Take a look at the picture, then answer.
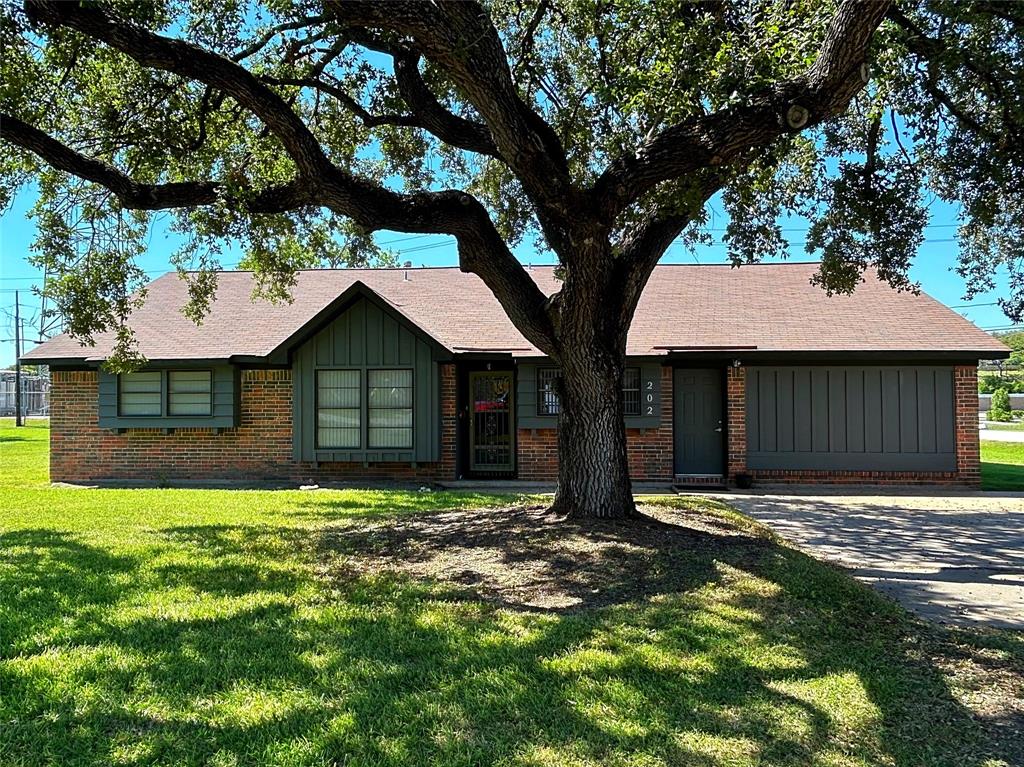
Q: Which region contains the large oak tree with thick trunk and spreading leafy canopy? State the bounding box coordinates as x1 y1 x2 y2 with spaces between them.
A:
0 0 1024 516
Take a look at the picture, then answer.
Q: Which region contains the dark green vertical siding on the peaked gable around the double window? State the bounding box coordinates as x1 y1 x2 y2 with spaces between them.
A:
292 298 440 463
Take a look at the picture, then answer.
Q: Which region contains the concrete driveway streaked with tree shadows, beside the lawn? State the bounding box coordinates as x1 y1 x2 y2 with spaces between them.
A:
722 493 1024 630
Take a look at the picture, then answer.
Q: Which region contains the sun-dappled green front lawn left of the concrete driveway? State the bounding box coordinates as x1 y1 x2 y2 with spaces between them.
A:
0 424 1021 767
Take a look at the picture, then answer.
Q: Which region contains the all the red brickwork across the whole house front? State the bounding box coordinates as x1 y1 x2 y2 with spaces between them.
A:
50 364 980 486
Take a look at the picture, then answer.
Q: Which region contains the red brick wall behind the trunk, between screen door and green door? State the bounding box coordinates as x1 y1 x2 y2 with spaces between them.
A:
516 368 673 482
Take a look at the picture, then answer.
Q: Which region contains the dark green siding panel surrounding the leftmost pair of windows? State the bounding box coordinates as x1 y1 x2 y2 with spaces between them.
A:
96 365 241 429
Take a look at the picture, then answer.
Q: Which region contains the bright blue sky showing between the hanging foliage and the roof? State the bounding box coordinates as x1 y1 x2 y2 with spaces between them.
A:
0 182 1009 368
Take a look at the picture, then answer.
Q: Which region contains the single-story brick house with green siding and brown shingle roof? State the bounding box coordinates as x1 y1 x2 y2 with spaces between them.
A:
24 263 1008 485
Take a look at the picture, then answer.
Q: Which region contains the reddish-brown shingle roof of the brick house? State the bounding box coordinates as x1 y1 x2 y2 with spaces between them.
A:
25 263 1007 361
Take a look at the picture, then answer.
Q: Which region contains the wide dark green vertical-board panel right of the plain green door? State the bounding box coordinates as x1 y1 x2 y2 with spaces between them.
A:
746 366 956 471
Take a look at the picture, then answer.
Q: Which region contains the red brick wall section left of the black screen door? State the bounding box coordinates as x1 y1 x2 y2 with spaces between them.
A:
50 365 455 482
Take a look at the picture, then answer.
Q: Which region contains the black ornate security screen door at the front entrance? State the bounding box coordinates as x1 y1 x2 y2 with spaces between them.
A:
469 371 515 474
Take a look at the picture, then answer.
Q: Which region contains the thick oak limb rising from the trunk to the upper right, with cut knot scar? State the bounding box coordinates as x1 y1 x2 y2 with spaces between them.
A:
593 0 889 219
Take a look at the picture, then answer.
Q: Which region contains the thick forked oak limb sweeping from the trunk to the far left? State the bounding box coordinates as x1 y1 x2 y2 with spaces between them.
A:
12 0 554 350
